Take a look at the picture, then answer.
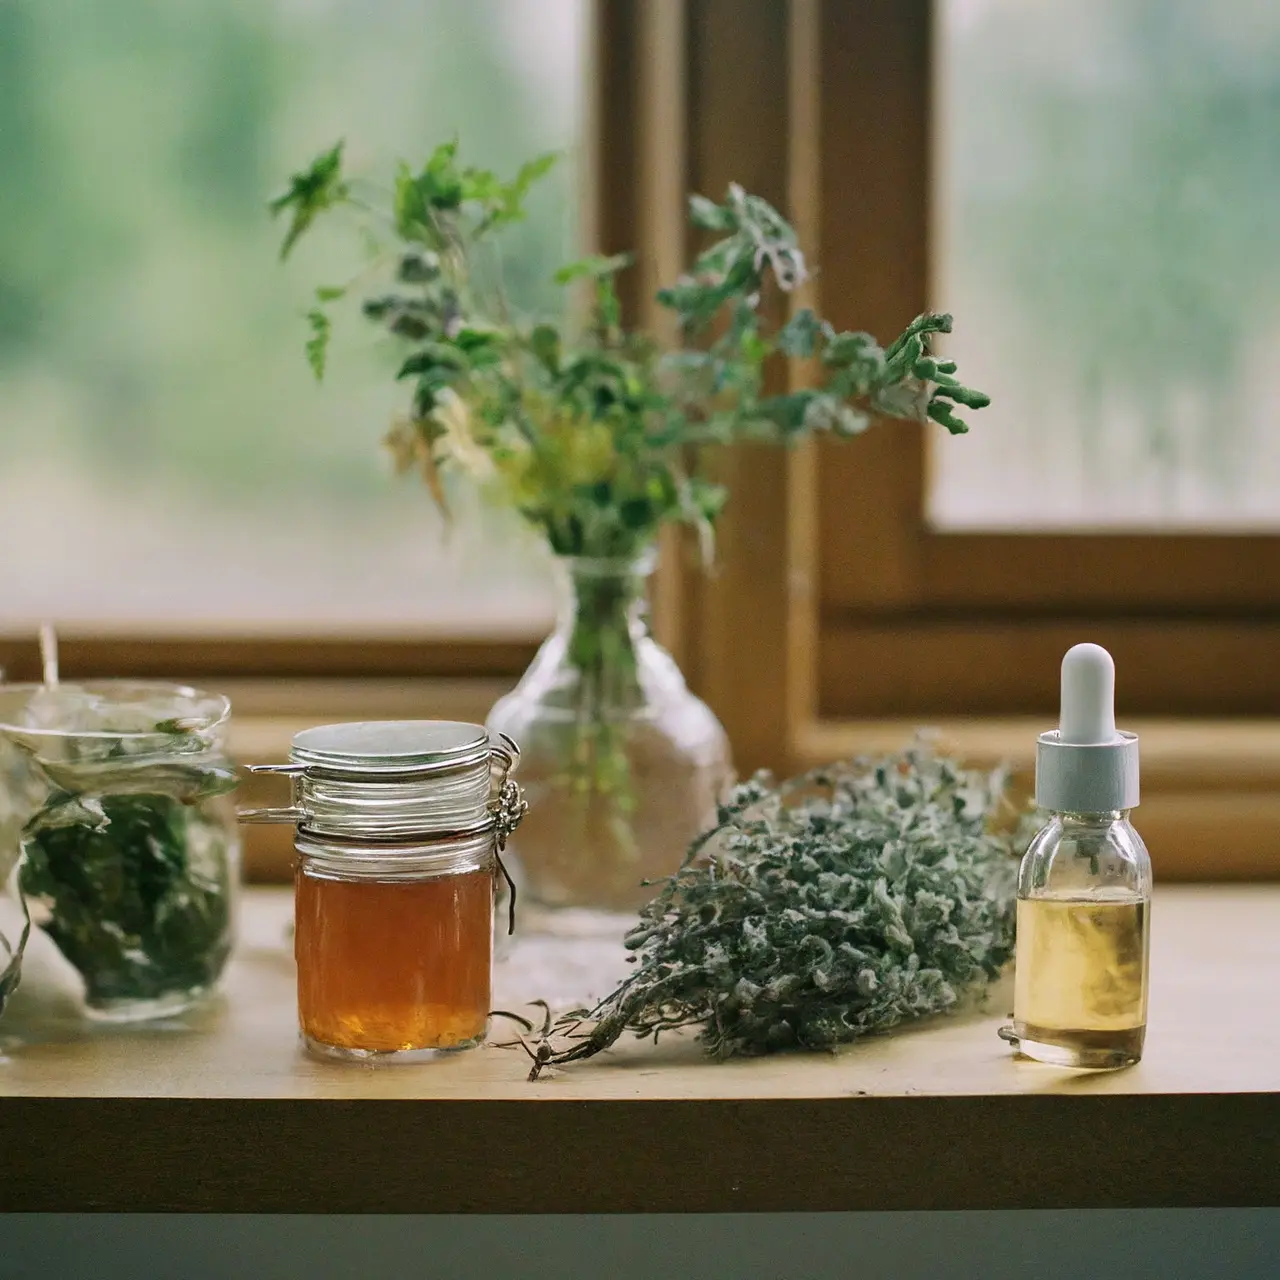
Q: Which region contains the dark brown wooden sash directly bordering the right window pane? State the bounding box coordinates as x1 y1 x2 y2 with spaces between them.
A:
814 0 1280 716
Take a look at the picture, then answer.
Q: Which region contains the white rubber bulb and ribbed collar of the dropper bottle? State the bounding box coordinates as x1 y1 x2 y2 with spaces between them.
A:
1036 644 1138 813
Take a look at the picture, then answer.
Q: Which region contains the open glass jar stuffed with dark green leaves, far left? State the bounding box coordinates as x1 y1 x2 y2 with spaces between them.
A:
0 681 239 1021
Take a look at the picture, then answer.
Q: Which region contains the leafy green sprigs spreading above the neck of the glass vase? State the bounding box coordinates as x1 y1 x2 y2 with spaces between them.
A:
271 142 988 558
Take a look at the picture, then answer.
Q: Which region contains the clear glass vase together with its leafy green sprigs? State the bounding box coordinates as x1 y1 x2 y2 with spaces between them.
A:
271 142 988 908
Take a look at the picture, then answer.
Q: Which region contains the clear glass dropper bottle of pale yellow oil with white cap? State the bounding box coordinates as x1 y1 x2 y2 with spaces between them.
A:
1002 644 1151 1068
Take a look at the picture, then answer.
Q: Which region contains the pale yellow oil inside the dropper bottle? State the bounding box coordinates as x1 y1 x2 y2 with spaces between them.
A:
1014 895 1151 1068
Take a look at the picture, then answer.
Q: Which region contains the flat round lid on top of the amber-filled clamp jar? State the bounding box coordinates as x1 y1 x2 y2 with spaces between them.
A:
289 721 490 774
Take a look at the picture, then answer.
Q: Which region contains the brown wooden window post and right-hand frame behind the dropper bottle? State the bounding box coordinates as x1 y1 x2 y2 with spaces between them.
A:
595 0 1280 878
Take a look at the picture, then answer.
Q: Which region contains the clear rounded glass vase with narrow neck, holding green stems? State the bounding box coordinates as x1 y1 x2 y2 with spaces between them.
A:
488 552 732 911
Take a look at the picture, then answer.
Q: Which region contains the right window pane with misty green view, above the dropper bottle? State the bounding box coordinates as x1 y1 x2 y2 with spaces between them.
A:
931 0 1280 531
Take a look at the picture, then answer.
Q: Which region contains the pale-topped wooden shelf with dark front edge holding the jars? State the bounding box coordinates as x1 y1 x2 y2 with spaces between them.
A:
0 886 1280 1212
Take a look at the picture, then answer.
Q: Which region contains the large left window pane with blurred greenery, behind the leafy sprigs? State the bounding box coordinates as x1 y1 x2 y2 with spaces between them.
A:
0 0 585 634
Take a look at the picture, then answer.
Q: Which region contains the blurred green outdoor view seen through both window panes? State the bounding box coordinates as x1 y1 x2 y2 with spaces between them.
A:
0 0 1280 632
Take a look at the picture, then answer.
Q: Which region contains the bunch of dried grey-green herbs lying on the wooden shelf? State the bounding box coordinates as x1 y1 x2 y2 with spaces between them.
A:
531 748 1025 1078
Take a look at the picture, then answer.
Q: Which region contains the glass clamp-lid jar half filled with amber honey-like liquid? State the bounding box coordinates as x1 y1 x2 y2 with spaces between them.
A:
241 721 526 1061
